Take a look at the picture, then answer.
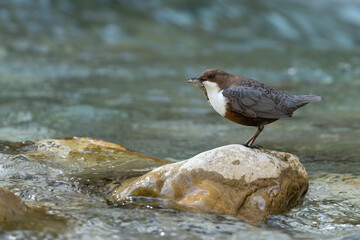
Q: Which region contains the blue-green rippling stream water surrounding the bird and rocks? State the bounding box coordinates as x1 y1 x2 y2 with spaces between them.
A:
0 0 360 239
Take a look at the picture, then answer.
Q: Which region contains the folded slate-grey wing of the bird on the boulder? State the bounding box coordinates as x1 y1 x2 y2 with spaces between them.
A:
223 86 291 119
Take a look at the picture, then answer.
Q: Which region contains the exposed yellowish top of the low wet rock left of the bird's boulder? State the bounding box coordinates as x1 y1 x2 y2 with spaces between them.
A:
24 136 168 170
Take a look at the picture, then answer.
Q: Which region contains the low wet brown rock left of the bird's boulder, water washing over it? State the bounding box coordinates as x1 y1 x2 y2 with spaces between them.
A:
0 136 169 196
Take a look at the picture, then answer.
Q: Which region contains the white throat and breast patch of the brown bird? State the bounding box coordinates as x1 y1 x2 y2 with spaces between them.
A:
203 81 227 116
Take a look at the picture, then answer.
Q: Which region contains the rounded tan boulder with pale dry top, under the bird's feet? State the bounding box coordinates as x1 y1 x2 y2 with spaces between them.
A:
108 145 308 222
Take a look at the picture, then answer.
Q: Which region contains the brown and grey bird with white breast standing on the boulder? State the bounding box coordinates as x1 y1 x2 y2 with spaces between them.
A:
188 68 322 148
